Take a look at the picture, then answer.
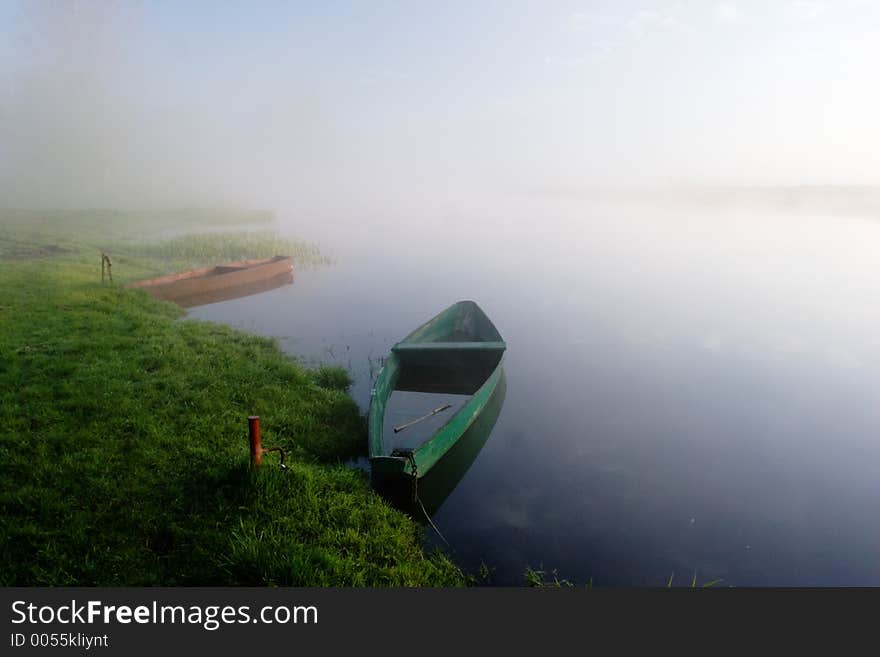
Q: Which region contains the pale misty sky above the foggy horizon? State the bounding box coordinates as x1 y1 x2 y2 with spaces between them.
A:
0 0 880 207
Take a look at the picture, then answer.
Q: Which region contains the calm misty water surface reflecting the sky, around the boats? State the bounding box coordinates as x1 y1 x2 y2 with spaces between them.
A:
190 199 880 586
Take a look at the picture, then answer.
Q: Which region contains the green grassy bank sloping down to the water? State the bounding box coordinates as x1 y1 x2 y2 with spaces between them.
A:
0 210 463 586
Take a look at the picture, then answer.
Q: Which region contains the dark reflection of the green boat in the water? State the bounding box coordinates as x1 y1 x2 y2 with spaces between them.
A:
373 367 507 521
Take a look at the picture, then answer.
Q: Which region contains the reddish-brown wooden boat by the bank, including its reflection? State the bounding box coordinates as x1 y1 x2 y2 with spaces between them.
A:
127 256 293 307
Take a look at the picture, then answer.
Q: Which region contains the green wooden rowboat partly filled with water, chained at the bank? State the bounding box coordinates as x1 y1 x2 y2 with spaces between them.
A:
369 301 507 483
